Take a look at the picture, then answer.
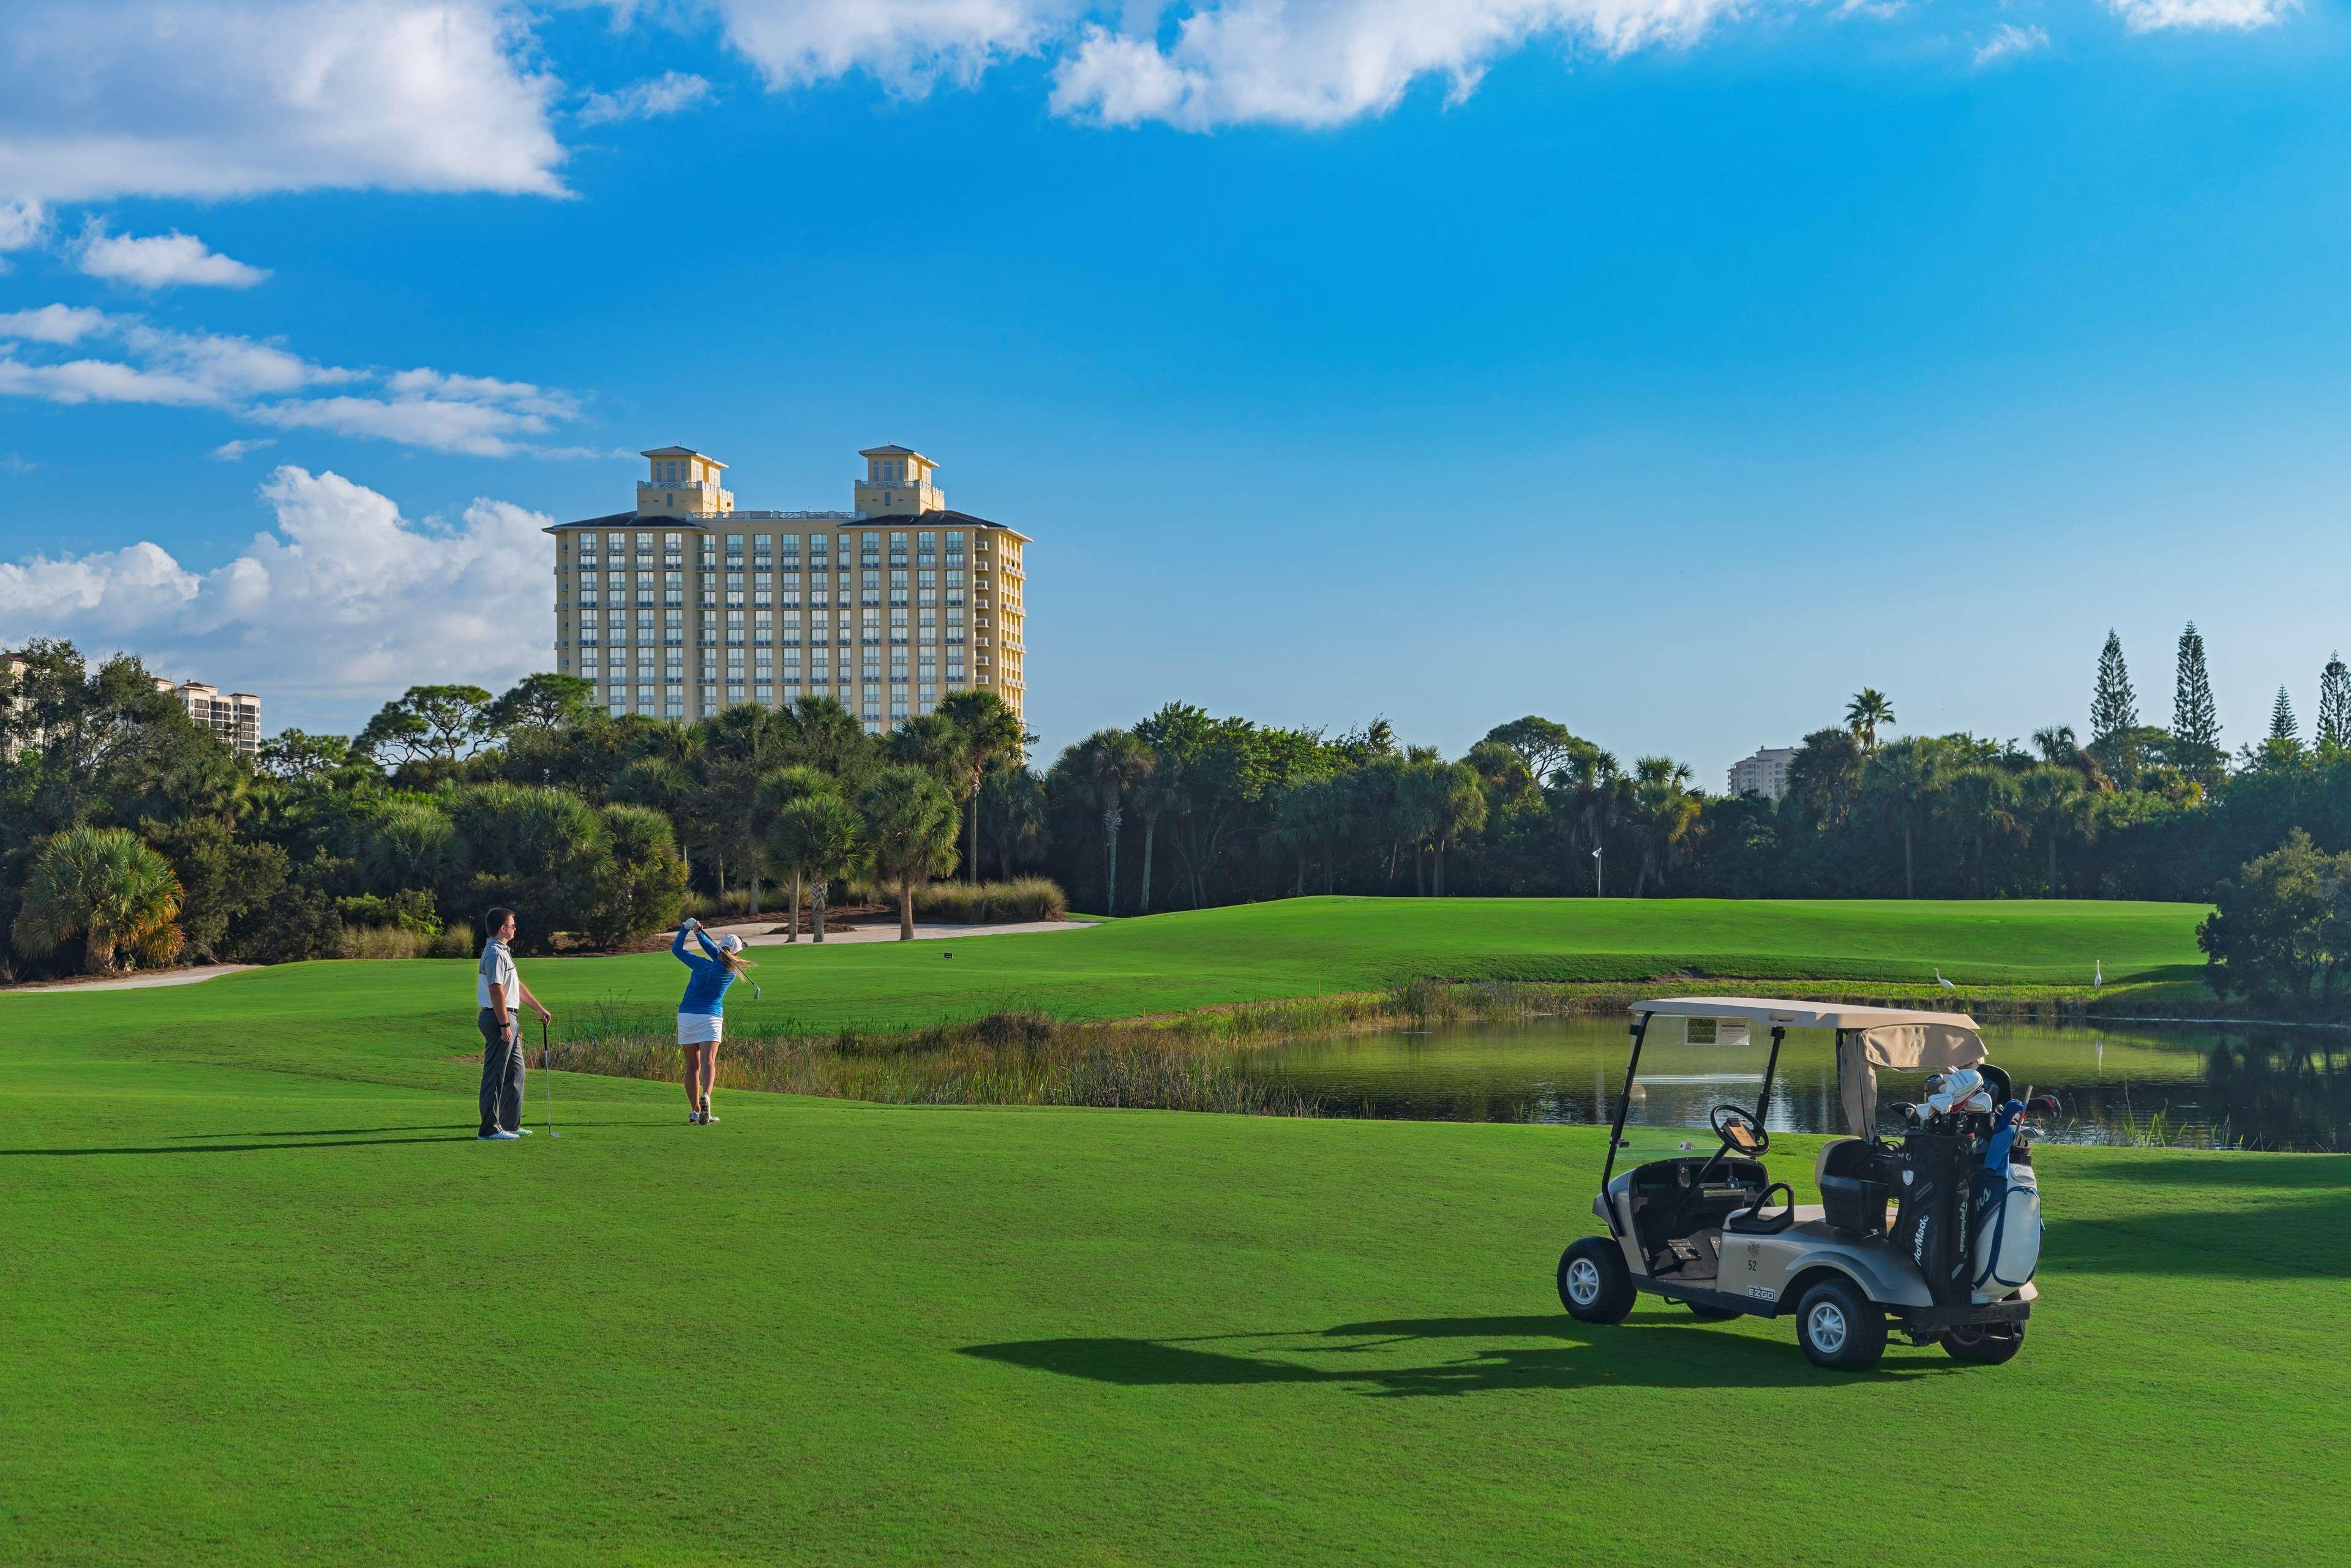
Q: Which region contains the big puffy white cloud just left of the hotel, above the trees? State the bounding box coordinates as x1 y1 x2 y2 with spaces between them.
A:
0 468 550 710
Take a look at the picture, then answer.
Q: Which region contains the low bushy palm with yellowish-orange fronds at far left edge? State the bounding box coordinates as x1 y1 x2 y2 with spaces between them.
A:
12 828 181 973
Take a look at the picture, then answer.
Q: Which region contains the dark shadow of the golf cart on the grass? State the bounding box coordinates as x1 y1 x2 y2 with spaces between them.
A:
959 1307 1959 1399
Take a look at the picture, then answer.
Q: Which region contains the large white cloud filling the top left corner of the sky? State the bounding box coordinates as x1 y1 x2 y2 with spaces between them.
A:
0 0 564 202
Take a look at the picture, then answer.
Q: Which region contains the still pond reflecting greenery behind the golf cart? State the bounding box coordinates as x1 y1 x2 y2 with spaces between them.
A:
1239 1016 2351 1150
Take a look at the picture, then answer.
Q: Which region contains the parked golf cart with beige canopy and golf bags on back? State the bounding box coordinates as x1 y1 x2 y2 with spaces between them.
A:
1559 997 2057 1368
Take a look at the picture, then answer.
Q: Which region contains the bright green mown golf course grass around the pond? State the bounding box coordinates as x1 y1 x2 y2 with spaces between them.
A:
13 901 2351 1566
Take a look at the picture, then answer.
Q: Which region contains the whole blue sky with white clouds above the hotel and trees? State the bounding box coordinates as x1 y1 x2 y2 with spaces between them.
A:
0 0 2351 787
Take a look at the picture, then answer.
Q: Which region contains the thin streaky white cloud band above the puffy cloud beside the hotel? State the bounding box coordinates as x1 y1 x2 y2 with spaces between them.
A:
0 306 604 456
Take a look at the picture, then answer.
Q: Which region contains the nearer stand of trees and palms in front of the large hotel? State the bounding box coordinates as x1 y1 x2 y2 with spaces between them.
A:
0 642 1030 978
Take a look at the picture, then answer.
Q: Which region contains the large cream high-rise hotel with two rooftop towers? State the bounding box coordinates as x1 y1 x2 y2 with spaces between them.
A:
548 447 1027 733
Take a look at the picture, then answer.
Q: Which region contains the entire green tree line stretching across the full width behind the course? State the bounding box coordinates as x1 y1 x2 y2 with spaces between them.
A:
13 625 2351 1001
